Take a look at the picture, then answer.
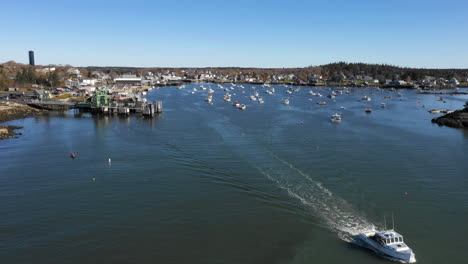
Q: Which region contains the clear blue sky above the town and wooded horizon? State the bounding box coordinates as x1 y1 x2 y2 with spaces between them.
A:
0 0 468 68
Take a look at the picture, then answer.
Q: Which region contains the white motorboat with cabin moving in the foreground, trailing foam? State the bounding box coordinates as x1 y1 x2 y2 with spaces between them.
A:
355 229 416 263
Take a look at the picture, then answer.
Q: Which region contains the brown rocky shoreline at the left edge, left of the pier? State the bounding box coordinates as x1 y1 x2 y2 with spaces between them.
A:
0 103 44 140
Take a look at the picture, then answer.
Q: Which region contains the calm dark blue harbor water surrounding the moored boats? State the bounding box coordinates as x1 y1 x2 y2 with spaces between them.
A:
0 85 468 263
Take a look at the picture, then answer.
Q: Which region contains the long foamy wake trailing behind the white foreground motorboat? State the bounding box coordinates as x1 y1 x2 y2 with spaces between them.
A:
210 115 375 242
